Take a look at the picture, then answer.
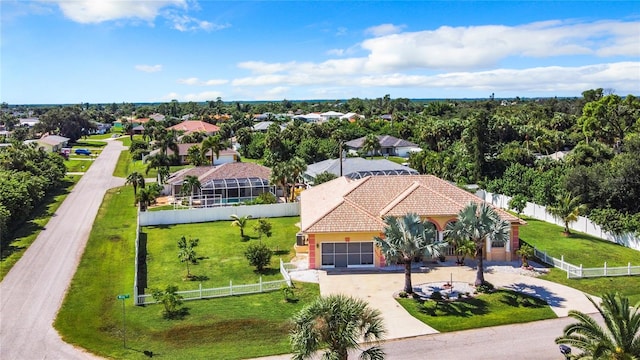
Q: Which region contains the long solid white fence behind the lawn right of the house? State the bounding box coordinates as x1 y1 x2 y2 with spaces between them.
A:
476 190 640 251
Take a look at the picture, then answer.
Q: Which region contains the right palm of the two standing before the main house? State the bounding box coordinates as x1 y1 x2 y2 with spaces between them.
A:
444 203 511 286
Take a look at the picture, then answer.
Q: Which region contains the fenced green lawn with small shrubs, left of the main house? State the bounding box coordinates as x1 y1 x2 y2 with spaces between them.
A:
143 216 300 290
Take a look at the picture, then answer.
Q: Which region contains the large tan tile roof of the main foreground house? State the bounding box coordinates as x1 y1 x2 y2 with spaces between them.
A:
300 175 521 233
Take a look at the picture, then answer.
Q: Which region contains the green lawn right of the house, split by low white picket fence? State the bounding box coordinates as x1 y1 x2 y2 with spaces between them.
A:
520 218 640 303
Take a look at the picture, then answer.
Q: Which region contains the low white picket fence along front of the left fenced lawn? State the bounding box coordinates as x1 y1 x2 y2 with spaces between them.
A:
135 260 292 305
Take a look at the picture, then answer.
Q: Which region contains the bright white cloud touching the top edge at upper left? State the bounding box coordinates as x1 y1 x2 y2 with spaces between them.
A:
44 0 187 24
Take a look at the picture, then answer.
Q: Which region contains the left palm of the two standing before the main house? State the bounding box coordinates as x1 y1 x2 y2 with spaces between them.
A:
374 213 442 293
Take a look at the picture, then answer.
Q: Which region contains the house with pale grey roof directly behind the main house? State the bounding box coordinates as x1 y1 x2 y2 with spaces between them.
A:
302 157 418 185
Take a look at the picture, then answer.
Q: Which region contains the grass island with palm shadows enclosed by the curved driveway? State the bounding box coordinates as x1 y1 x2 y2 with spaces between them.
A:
398 290 556 332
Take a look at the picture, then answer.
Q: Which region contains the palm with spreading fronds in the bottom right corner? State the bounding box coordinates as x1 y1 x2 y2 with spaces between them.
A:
556 293 640 360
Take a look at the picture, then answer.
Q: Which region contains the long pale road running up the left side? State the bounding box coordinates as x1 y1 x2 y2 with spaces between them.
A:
0 141 124 360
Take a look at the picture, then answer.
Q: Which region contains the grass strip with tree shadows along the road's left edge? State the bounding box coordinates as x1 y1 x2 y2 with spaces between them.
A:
0 175 80 280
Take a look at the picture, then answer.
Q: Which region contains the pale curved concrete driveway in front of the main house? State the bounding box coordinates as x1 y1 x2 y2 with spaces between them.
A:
319 266 596 339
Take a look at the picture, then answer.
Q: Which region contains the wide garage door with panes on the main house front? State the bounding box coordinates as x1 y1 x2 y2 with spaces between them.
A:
321 242 373 268
